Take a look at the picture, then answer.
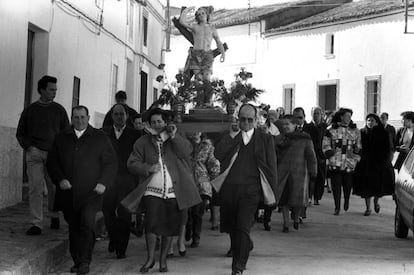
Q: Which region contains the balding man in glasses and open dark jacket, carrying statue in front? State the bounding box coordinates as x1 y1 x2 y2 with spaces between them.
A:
215 104 277 274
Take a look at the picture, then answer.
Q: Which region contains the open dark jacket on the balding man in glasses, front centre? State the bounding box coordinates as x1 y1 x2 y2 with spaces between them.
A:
214 129 277 205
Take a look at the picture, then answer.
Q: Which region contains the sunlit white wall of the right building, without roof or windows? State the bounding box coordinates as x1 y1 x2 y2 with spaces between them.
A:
263 13 414 121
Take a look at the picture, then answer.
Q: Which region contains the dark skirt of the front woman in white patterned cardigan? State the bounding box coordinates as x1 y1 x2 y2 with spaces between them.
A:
143 196 183 236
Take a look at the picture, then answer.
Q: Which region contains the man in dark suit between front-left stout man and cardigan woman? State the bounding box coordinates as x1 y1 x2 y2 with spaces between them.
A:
102 103 141 259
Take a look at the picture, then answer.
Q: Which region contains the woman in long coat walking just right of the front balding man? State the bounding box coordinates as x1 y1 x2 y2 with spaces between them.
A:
275 115 317 232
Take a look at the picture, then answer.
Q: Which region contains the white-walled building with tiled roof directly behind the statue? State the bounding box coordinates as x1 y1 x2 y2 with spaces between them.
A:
166 0 351 95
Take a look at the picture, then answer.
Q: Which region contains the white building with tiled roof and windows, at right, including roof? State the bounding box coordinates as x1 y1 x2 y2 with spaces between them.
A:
261 0 414 126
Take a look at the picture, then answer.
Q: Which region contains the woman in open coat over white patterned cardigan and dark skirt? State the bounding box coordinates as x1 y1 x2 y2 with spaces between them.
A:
127 108 201 273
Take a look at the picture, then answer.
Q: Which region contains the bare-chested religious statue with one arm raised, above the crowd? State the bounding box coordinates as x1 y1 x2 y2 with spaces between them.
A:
173 6 226 107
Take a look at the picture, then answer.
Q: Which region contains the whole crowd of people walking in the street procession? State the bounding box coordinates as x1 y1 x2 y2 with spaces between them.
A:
16 76 414 274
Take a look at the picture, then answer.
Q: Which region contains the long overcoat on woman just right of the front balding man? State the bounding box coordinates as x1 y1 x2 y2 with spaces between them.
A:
275 131 317 207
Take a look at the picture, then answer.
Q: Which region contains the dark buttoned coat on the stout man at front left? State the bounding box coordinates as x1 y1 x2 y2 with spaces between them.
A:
47 125 118 210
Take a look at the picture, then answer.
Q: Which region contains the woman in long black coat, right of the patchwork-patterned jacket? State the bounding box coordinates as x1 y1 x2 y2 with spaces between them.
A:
354 114 395 216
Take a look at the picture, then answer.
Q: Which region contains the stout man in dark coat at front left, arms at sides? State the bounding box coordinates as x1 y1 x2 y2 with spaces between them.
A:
47 106 118 274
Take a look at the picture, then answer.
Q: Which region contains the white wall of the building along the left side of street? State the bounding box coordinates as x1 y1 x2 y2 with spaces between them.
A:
0 0 165 208
